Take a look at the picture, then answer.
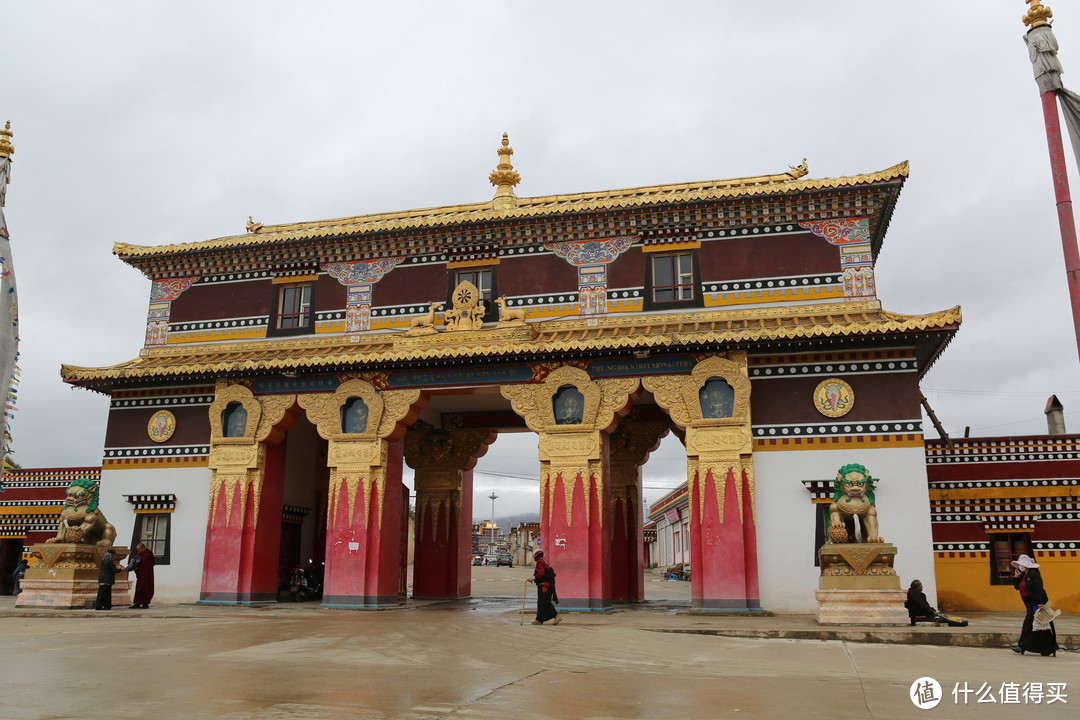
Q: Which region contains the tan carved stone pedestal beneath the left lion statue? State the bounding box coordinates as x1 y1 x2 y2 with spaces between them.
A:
15 543 132 609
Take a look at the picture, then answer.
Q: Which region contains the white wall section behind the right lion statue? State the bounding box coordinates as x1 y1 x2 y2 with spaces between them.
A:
754 447 937 613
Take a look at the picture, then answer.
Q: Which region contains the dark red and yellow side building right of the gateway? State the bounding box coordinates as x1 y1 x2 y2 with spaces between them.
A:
927 397 1080 613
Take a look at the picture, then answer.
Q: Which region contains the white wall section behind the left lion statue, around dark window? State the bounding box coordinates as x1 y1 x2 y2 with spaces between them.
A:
100 467 211 602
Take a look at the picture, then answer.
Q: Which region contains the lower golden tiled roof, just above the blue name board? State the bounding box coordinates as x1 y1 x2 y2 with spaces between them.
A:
60 302 961 385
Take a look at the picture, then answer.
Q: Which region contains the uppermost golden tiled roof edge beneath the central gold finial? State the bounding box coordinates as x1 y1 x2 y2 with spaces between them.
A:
112 160 909 258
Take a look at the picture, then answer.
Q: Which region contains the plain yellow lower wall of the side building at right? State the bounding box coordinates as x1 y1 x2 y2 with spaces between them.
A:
934 555 1080 612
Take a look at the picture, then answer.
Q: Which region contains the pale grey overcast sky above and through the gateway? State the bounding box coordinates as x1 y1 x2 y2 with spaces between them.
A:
0 0 1080 517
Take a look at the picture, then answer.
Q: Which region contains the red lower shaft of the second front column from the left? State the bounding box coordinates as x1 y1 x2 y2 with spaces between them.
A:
323 440 402 608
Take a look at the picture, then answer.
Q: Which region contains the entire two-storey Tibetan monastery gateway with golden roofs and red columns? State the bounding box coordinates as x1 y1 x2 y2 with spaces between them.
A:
62 136 960 612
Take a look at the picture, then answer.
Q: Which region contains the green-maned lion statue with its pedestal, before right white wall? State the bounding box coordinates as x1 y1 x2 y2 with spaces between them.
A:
816 465 909 625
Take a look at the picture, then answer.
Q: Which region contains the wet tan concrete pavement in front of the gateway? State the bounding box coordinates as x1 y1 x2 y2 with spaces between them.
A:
0 569 1080 720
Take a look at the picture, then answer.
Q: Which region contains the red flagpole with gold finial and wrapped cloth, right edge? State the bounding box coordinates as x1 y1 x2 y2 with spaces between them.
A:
1023 0 1080 355
